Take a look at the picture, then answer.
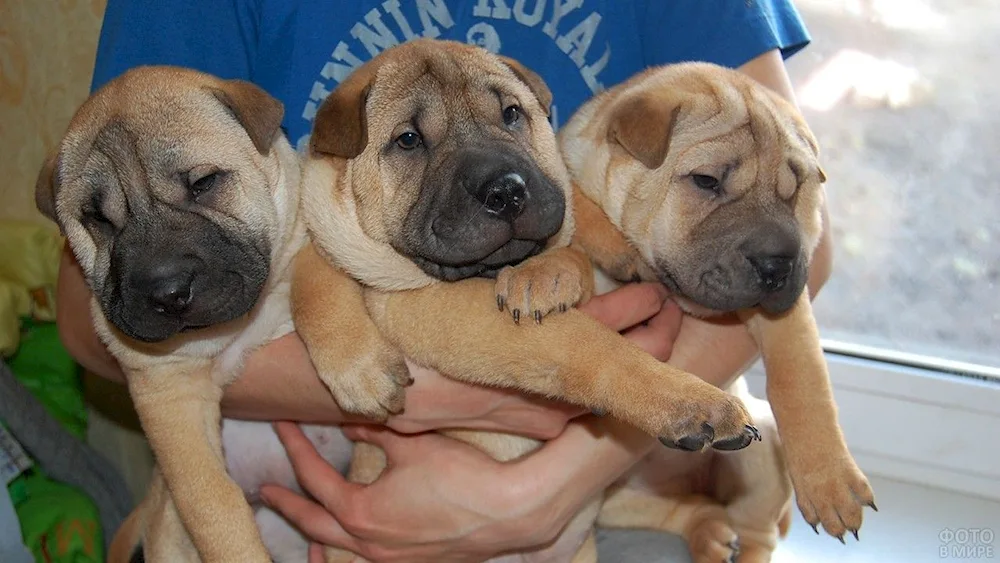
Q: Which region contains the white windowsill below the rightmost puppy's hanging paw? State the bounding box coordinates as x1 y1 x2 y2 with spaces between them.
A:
772 477 1000 563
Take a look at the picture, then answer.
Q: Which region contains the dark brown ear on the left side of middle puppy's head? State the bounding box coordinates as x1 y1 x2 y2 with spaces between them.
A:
309 63 375 158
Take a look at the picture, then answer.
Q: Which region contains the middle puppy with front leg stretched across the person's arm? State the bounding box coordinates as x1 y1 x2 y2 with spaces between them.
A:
292 40 757 561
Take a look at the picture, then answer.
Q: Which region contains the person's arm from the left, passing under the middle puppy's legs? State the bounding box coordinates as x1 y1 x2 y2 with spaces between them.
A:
57 245 679 439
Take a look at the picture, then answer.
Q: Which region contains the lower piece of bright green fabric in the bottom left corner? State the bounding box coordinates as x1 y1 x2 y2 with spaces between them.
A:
10 469 105 563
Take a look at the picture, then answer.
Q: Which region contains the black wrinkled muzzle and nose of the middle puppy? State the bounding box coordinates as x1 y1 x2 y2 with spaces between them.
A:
396 117 566 281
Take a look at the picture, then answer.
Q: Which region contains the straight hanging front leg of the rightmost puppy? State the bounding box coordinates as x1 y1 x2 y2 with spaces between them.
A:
744 292 874 541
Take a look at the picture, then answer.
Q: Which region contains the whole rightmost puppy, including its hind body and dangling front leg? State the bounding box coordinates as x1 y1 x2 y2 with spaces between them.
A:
559 63 874 562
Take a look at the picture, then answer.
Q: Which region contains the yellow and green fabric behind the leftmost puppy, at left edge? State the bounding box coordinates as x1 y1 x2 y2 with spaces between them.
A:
0 221 105 563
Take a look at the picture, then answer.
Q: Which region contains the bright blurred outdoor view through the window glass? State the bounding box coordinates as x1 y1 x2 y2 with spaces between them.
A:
788 0 1000 368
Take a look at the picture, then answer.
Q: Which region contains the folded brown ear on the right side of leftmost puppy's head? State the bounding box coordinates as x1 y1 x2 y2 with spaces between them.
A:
212 80 285 154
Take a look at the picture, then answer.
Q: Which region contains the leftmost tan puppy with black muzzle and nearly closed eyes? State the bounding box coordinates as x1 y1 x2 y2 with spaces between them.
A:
36 67 304 563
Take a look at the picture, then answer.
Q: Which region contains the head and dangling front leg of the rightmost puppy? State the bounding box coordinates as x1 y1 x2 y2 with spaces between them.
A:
559 63 874 561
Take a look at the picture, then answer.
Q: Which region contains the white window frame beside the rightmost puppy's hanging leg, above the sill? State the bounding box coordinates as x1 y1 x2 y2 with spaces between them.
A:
746 340 1000 500
